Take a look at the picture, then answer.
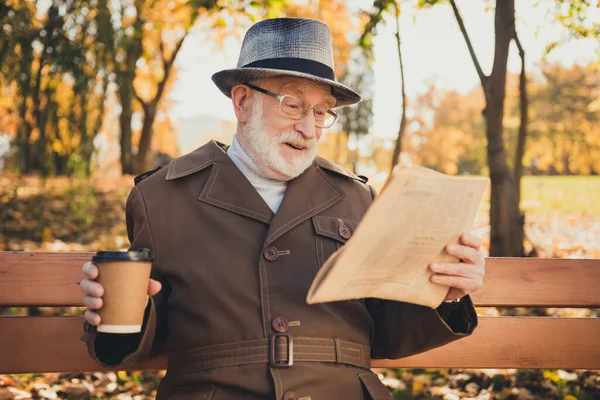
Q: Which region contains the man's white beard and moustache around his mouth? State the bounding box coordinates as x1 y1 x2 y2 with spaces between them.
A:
240 96 317 181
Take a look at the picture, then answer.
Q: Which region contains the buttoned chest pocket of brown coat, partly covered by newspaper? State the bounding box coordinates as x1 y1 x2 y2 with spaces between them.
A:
312 215 358 269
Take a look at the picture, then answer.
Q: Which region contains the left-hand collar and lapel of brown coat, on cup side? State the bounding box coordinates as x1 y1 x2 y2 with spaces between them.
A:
165 141 273 224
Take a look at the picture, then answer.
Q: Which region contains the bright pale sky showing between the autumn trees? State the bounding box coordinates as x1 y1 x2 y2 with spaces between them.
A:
170 0 600 153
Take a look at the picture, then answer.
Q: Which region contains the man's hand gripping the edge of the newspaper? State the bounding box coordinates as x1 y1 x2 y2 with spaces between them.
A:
429 233 485 301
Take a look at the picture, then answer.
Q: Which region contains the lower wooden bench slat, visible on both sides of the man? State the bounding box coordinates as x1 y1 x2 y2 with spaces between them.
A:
0 317 600 373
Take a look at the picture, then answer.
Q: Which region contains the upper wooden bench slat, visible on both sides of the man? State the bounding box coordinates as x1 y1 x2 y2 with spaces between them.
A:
0 252 600 307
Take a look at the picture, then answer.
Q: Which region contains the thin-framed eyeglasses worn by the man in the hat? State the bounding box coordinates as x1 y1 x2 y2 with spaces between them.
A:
246 83 338 129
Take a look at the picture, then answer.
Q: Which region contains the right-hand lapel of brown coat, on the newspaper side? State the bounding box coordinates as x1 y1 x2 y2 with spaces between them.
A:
265 164 346 246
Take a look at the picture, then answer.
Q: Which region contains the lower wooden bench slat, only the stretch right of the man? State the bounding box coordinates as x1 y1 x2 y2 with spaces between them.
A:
373 317 600 369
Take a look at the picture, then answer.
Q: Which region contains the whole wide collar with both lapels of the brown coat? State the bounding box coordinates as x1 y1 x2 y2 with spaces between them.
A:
165 140 361 238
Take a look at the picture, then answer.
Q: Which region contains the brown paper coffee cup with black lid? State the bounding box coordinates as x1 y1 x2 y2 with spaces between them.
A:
92 249 154 333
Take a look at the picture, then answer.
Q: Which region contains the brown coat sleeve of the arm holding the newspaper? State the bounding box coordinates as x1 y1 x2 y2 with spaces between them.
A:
365 185 478 359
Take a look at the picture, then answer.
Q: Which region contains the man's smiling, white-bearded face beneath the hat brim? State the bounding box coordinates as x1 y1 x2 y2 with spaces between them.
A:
238 77 335 181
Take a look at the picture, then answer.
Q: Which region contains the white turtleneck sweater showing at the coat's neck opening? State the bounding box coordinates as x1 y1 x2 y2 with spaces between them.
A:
227 135 287 213
